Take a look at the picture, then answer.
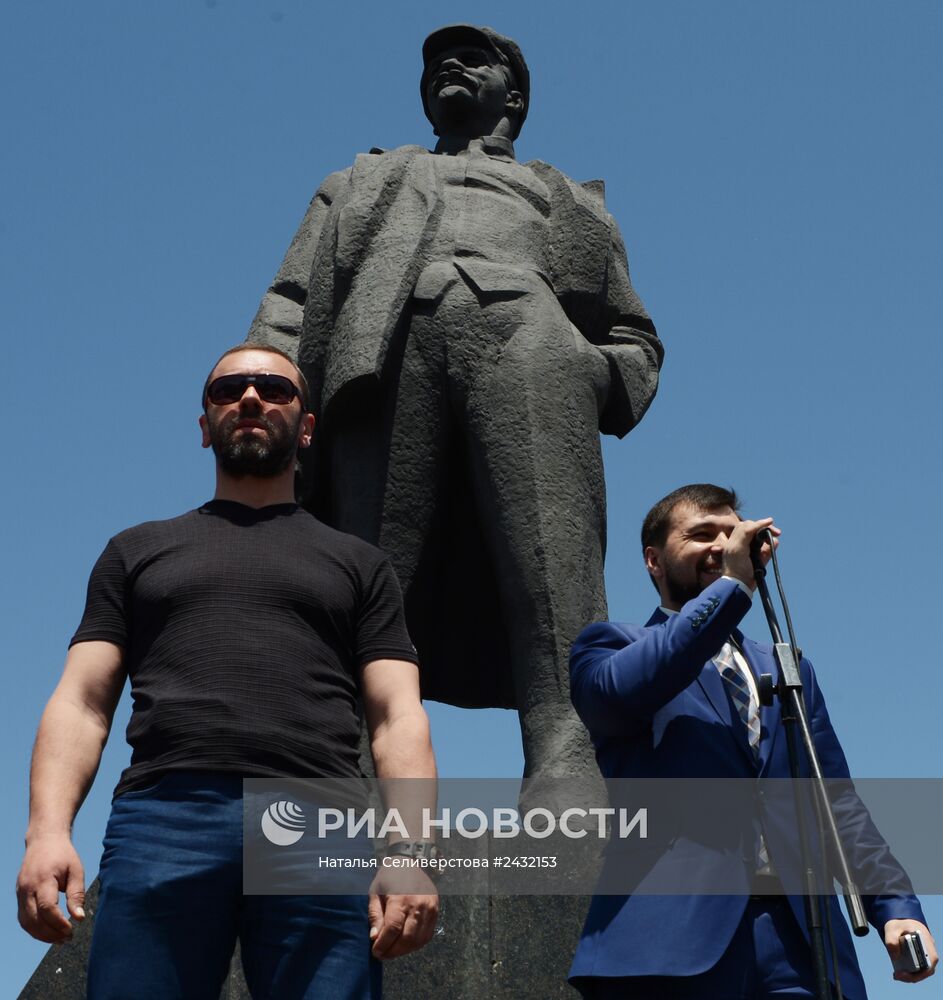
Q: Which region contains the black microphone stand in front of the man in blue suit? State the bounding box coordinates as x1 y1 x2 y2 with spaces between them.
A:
750 529 868 1000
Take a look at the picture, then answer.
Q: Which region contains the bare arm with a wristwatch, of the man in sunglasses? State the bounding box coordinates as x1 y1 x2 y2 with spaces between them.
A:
361 660 439 958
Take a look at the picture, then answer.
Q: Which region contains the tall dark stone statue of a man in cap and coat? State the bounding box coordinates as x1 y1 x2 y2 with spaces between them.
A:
249 25 662 777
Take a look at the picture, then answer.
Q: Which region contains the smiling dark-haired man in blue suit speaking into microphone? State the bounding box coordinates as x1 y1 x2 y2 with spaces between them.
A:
570 484 937 1000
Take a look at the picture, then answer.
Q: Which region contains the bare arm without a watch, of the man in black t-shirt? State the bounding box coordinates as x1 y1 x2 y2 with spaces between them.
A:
16 642 125 943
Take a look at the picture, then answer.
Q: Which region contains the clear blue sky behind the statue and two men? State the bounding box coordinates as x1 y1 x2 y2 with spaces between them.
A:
0 0 943 1000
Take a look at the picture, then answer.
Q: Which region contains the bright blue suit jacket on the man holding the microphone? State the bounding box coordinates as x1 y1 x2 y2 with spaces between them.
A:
570 579 924 997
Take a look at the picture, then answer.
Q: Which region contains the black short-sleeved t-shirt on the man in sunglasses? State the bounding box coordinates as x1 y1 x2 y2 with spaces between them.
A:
72 500 416 795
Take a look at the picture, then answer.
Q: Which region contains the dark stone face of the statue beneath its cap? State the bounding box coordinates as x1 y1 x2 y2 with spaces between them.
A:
426 45 520 132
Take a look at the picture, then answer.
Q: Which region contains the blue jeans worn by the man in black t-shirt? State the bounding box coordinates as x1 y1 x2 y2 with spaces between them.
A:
88 773 381 1000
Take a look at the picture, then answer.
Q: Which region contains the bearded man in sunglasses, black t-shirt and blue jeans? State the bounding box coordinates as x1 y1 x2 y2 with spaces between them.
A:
17 345 437 1000
